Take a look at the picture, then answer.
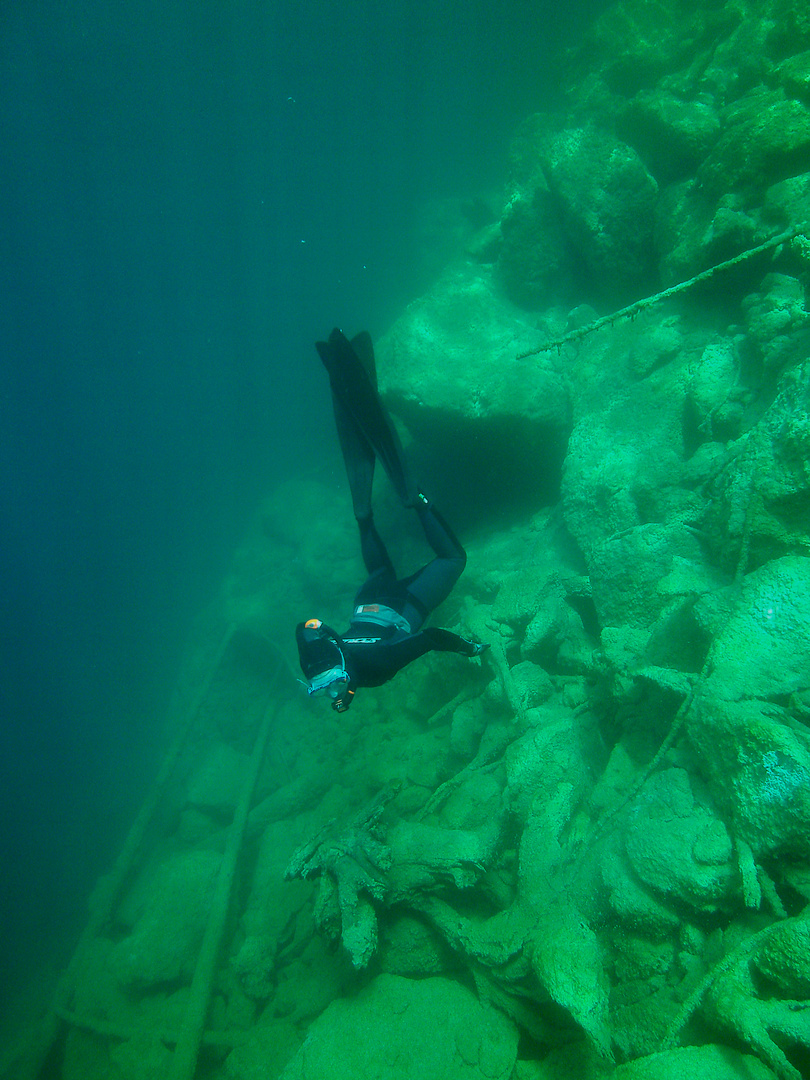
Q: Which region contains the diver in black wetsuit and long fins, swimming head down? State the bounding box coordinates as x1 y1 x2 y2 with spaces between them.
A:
296 329 489 713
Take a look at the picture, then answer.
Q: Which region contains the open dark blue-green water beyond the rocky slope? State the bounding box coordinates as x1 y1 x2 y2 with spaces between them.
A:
0 0 606 1019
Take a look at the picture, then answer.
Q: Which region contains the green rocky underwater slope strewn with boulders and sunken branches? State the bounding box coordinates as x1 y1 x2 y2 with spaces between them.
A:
17 0 810 1080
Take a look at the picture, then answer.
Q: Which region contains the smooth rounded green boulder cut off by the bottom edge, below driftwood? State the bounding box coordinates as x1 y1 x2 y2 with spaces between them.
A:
280 974 517 1080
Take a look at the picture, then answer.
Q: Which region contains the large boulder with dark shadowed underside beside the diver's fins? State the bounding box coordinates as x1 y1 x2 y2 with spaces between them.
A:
377 265 570 516
